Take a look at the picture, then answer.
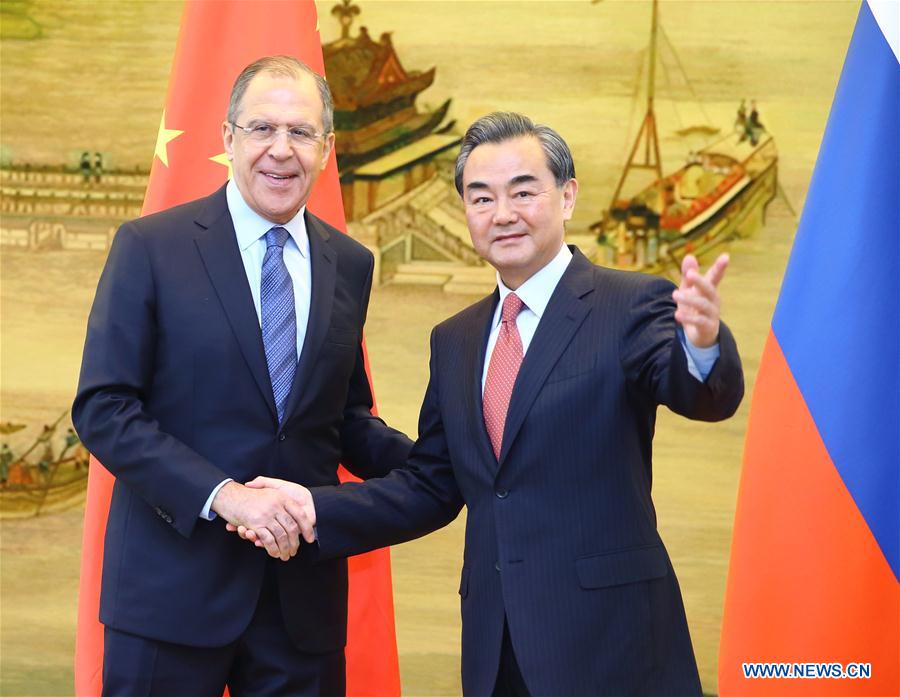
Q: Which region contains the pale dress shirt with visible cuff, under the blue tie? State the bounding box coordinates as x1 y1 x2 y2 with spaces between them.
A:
200 179 312 520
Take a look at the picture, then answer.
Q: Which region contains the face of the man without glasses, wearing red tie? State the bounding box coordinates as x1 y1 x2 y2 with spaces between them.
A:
463 136 578 289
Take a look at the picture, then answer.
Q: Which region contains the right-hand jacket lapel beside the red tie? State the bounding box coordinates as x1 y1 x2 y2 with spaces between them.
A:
498 248 594 467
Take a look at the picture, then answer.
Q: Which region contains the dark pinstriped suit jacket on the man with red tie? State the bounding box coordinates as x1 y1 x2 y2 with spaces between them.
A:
314 250 743 695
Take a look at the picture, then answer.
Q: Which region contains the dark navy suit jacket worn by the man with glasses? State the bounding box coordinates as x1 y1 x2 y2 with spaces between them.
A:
72 188 411 652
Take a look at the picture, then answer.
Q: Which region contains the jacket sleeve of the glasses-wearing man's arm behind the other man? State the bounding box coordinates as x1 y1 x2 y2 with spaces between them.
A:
341 250 412 479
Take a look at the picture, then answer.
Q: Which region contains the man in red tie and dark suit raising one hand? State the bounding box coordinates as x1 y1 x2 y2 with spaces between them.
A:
238 113 743 696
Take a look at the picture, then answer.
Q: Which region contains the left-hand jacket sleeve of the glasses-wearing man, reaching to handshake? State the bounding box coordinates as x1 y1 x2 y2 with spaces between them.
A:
72 223 228 537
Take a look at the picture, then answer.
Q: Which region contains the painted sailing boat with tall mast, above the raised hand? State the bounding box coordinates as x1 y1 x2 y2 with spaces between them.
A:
591 0 778 277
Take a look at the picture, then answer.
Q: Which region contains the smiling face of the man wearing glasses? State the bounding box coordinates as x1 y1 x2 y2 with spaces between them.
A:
222 73 334 223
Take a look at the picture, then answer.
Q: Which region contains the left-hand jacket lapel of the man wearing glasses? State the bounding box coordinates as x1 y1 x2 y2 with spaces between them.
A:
194 187 278 420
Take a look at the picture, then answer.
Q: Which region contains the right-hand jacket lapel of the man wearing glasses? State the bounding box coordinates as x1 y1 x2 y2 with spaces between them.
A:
284 211 337 422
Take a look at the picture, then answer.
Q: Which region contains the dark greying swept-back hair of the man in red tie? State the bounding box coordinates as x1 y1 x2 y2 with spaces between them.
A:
455 111 575 196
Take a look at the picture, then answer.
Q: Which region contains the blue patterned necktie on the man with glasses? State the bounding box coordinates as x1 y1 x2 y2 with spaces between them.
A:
259 227 297 423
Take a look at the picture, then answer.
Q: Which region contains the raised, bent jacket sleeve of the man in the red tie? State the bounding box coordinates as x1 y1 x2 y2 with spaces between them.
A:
620 279 744 421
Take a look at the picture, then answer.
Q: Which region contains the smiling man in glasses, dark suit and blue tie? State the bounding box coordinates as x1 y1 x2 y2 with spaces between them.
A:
72 56 411 697
